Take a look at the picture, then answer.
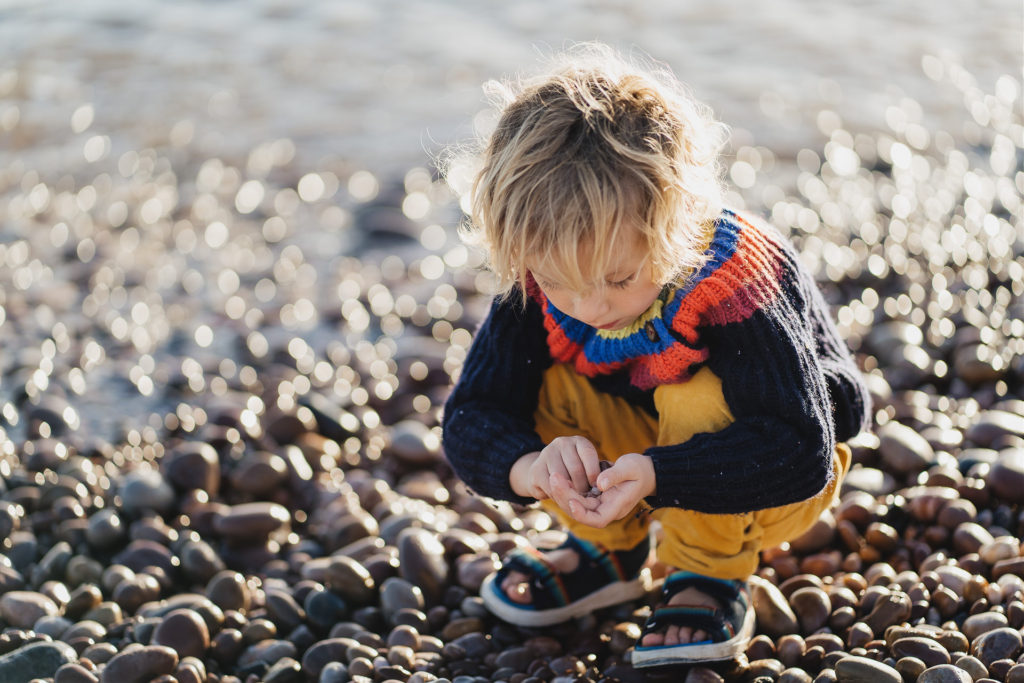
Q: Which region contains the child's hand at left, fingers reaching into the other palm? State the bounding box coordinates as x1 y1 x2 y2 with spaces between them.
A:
509 436 601 501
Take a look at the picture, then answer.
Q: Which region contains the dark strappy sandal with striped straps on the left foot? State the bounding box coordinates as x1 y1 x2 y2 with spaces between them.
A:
480 533 651 627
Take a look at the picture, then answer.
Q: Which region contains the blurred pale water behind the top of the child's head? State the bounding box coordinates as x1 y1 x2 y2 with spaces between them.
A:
0 0 1024 175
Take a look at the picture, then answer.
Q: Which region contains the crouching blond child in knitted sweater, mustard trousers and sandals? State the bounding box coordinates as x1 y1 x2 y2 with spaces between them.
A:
443 45 868 666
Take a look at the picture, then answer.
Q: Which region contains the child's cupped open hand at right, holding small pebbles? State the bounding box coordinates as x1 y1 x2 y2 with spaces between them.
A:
551 453 655 528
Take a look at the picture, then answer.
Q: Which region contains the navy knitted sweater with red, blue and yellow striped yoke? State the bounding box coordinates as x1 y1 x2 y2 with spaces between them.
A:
443 211 869 513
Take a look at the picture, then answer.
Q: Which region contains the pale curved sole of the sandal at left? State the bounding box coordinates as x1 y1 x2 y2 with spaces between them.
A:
480 569 651 627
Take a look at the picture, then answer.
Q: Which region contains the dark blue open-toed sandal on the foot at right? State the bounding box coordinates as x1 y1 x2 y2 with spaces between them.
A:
631 571 756 669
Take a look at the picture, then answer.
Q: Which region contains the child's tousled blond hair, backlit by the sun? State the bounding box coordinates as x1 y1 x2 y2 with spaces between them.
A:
445 43 727 296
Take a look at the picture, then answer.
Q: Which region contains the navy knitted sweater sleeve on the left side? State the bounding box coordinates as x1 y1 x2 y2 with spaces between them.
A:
441 294 551 504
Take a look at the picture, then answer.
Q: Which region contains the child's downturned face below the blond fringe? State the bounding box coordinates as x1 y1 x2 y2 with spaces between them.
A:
526 233 662 330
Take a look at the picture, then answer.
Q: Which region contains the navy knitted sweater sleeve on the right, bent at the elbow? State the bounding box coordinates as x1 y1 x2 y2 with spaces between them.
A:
645 240 858 514
